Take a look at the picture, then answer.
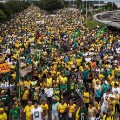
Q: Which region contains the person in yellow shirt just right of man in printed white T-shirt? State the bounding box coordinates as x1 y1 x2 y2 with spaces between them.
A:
40 100 48 120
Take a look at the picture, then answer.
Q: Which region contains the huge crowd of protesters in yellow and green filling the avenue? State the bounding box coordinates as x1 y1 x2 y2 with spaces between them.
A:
0 5 120 120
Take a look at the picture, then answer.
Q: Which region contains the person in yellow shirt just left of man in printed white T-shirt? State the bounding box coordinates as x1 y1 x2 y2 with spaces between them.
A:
24 101 34 120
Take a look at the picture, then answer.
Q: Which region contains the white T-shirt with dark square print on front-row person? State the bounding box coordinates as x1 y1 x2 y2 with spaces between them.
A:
31 107 43 120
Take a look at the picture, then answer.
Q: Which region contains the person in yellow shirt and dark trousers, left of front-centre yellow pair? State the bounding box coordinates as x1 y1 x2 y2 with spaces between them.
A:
58 99 67 120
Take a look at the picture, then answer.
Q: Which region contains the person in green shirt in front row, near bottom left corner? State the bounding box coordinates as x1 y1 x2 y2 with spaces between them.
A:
9 103 20 120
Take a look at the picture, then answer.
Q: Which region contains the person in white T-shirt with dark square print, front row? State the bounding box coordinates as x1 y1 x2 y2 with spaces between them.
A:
31 102 43 120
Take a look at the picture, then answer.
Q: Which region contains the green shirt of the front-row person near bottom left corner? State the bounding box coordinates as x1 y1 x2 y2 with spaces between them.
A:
9 107 20 120
